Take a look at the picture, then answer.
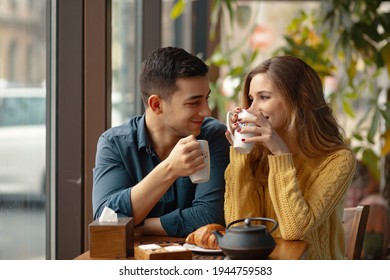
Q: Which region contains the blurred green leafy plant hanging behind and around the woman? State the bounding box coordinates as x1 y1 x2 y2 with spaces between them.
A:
172 0 390 201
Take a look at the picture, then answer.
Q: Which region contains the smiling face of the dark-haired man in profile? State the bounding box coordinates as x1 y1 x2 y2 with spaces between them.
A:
162 76 211 138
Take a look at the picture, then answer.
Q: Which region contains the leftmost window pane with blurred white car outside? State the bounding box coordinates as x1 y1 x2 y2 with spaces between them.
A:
0 0 47 260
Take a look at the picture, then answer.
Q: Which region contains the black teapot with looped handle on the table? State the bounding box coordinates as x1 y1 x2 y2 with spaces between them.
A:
213 218 278 260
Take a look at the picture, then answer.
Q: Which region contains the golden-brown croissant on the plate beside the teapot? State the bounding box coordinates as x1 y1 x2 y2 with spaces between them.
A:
186 224 225 250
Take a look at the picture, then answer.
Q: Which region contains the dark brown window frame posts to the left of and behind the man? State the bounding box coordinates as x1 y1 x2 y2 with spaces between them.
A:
54 0 161 259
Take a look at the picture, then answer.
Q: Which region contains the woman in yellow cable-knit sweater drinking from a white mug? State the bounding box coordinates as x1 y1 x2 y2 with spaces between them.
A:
224 56 355 259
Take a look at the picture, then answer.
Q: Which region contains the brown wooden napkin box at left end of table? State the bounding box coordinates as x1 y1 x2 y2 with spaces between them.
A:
89 217 134 258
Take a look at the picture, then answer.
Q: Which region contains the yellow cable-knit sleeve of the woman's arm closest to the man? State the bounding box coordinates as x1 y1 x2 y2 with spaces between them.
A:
224 147 262 224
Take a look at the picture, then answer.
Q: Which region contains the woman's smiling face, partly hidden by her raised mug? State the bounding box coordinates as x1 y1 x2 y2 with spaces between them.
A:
248 73 288 132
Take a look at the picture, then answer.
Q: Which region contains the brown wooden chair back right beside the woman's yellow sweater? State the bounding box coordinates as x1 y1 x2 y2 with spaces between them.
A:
343 205 370 260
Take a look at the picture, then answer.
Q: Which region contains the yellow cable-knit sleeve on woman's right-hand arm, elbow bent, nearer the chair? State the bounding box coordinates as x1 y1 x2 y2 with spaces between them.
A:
268 150 355 240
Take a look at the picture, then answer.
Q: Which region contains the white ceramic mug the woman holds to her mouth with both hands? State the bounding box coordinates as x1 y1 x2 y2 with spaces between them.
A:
226 109 255 154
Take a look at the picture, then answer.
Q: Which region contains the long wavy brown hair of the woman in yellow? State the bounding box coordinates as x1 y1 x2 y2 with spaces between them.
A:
241 56 348 183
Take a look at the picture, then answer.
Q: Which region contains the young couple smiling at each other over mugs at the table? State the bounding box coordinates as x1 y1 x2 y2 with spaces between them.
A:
93 47 355 259
